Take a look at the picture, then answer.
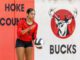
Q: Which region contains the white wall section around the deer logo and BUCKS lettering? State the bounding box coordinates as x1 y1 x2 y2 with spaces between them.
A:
35 0 80 60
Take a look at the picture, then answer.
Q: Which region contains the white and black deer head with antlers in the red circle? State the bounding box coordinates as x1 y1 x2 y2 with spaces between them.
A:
49 9 77 37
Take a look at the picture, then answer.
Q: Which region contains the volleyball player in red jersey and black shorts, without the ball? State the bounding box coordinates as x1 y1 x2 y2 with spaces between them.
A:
16 8 38 60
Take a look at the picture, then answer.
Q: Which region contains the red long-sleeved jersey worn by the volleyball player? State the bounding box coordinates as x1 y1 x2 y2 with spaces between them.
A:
17 20 38 41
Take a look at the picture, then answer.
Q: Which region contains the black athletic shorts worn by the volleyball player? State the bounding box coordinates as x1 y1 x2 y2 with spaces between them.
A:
16 39 33 48
